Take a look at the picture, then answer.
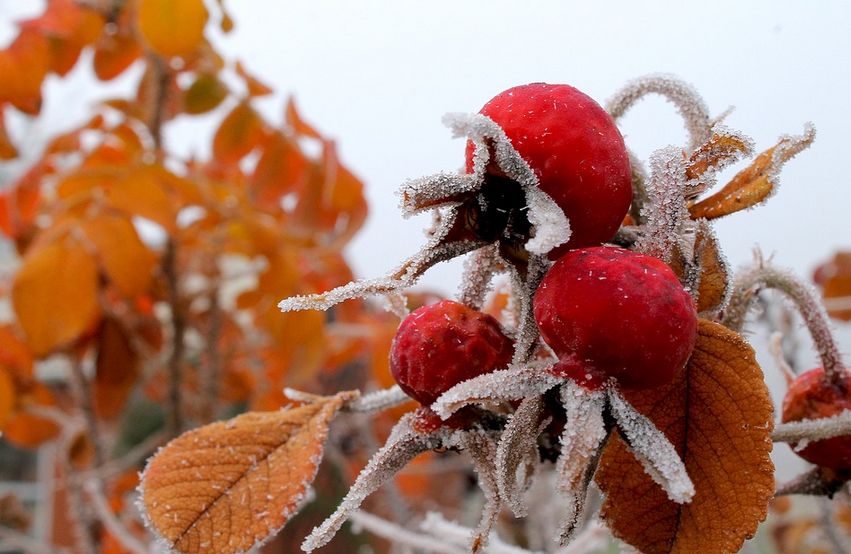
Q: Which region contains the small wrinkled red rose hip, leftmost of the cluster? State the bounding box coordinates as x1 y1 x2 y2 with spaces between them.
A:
390 300 514 406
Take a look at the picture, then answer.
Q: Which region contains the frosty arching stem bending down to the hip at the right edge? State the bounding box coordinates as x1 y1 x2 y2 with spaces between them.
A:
722 261 846 380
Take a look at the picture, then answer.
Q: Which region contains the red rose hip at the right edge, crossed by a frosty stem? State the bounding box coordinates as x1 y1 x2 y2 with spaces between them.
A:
781 367 851 469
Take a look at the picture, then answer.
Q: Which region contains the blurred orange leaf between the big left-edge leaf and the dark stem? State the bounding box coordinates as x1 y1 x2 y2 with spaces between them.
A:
82 214 156 298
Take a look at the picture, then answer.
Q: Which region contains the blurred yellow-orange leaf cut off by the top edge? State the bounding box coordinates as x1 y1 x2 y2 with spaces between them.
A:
138 0 207 57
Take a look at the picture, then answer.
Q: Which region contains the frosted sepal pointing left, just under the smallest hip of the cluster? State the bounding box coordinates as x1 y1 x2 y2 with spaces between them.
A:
431 363 562 419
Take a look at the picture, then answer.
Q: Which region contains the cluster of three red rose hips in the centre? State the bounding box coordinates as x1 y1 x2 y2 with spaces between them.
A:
390 83 697 414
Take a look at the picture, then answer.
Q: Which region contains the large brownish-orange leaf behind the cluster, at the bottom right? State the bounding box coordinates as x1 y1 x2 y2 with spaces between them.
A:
596 320 774 554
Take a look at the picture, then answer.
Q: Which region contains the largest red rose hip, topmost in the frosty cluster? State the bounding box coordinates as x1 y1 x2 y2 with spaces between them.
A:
466 83 632 254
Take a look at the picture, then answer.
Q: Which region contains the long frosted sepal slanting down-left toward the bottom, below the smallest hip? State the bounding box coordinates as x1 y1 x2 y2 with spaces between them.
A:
301 414 443 552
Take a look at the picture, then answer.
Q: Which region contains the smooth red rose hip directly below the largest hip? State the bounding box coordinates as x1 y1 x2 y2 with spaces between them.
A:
534 246 697 389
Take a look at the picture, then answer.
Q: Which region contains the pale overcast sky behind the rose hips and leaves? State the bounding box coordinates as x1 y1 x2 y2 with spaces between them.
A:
0 0 851 474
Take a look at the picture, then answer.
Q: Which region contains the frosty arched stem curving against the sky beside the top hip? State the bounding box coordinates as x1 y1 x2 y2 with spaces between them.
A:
606 75 712 150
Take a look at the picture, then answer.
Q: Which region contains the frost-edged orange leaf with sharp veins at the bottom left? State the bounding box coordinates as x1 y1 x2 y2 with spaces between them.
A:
140 393 352 553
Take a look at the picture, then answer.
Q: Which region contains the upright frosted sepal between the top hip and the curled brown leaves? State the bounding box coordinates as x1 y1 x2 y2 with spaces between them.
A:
635 146 689 262
